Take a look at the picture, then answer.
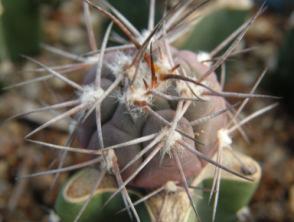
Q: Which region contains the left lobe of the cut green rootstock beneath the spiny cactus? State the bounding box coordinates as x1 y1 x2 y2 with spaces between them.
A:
55 168 152 222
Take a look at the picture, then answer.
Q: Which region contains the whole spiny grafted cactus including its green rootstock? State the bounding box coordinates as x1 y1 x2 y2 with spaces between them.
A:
6 0 277 221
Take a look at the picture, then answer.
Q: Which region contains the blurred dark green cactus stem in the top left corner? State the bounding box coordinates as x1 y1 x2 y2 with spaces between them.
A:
0 0 41 60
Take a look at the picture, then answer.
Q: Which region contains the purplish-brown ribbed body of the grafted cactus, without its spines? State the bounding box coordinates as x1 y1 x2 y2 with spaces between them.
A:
79 47 227 188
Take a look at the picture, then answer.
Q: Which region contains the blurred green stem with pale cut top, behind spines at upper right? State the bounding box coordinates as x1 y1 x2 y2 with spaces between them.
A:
181 0 251 51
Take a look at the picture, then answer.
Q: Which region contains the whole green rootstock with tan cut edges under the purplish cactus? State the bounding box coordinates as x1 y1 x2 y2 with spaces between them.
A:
55 149 261 222
